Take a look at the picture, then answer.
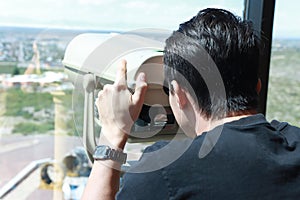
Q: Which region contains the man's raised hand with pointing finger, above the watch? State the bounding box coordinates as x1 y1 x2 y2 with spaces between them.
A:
96 60 147 149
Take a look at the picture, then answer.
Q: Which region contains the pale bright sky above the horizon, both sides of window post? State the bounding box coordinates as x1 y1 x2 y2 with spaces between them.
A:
0 0 300 38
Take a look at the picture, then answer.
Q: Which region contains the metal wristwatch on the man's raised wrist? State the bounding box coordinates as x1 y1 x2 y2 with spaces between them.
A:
93 145 127 164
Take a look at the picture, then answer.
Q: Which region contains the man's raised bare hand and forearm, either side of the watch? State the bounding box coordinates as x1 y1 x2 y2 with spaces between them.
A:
82 61 147 200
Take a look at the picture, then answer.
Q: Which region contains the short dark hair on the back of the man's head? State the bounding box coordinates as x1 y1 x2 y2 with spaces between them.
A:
164 8 260 119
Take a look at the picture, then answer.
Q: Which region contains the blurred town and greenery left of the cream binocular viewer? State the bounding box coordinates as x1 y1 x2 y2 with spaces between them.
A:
0 27 110 135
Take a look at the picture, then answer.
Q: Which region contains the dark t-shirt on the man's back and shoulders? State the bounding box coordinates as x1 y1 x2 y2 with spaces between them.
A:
117 114 300 200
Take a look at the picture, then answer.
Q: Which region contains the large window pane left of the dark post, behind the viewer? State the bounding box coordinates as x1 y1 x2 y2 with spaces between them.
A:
0 0 244 199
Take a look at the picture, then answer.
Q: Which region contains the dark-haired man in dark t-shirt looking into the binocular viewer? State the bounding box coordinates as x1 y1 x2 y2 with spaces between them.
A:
83 9 300 199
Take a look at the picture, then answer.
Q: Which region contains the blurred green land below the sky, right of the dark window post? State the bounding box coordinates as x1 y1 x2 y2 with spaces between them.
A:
266 39 300 126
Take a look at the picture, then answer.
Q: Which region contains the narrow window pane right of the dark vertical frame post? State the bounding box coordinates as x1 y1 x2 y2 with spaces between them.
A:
267 0 300 126
